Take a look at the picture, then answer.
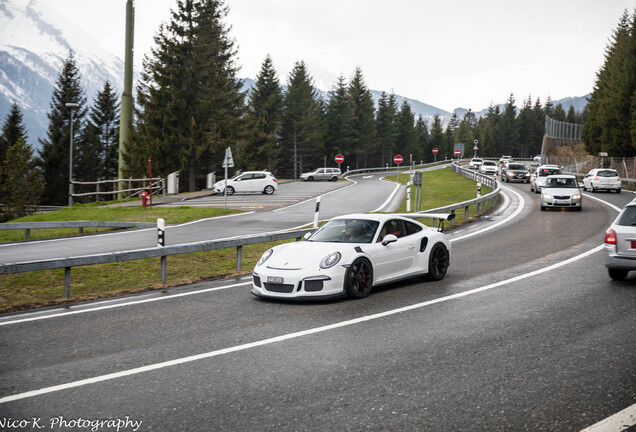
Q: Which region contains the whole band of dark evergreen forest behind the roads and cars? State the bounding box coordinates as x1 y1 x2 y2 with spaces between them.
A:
0 0 636 209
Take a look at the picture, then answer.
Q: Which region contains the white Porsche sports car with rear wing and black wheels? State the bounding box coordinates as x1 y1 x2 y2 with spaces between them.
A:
252 214 455 299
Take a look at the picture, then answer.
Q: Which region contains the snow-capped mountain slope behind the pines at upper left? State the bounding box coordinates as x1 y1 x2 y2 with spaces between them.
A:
0 0 124 148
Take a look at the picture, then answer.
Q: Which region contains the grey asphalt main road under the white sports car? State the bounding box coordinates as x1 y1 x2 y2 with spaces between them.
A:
0 176 636 432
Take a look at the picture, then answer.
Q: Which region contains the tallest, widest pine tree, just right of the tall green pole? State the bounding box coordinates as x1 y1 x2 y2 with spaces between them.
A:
133 0 244 191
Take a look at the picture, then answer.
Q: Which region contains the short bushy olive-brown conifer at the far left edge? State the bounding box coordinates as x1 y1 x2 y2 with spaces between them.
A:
0 137 44 222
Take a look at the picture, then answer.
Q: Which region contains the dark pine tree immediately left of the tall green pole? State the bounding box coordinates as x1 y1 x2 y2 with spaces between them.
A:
77 81 119 186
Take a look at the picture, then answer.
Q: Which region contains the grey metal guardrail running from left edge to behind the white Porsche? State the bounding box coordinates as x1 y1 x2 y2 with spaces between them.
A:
0 230 315 298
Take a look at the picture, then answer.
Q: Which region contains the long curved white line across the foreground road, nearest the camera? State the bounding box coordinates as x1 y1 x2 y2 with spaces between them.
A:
0 241 603 404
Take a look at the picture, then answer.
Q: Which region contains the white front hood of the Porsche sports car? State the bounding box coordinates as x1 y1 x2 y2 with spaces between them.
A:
265 241 356 270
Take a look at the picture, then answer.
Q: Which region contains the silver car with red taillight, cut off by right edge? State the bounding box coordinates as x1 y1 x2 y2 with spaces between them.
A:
604 199 636 281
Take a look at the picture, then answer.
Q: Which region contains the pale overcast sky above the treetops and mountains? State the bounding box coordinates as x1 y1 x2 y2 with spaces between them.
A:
53 0 636 111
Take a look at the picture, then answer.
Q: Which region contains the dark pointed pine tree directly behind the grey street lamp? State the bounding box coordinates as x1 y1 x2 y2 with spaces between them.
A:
39 52 86 205
